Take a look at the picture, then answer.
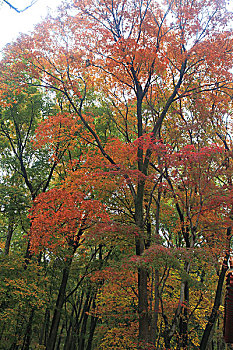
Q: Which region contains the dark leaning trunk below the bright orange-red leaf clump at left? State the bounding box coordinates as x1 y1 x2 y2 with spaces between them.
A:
46 258 72 350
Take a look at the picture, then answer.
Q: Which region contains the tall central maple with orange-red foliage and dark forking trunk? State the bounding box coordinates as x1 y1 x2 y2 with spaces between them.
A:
0 0 232 349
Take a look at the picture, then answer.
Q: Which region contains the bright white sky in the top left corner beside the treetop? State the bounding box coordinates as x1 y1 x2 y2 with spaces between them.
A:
0 0 62 49
